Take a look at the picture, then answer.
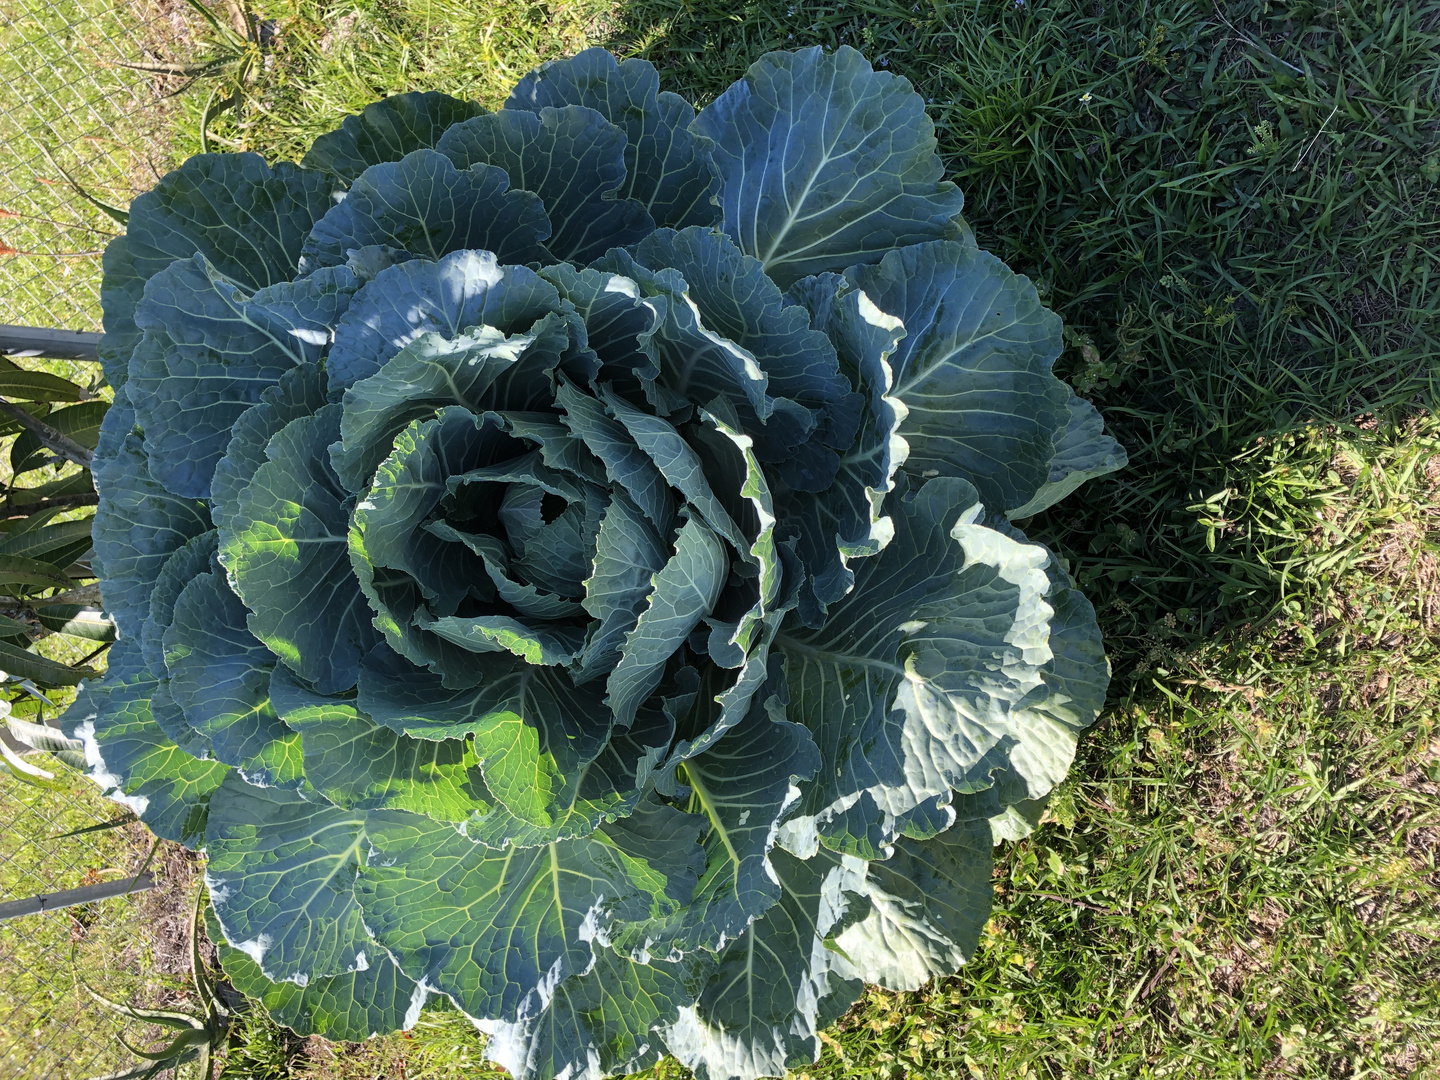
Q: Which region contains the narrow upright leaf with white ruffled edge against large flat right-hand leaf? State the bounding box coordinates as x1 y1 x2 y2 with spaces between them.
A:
778 274 910 626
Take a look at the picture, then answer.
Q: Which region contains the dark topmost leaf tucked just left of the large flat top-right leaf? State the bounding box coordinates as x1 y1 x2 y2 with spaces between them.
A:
505 49 720 229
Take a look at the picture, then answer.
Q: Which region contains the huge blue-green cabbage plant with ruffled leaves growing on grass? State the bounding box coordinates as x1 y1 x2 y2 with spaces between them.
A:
68 49 1125 1080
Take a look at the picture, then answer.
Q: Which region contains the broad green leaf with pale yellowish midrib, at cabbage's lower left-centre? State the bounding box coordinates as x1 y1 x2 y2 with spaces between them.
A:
356 811 679 1021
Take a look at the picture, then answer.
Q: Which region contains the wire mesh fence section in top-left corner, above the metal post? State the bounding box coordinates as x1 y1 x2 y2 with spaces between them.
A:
0 0 189 330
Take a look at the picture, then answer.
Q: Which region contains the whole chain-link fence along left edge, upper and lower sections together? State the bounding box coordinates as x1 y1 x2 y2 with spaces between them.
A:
0 0 203 1080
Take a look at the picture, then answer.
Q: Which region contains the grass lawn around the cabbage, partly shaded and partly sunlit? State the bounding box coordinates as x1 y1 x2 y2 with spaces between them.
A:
0 3 1440 1076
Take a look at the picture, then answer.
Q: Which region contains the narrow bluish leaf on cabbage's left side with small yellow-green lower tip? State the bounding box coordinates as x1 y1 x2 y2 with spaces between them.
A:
164 570 304 786
